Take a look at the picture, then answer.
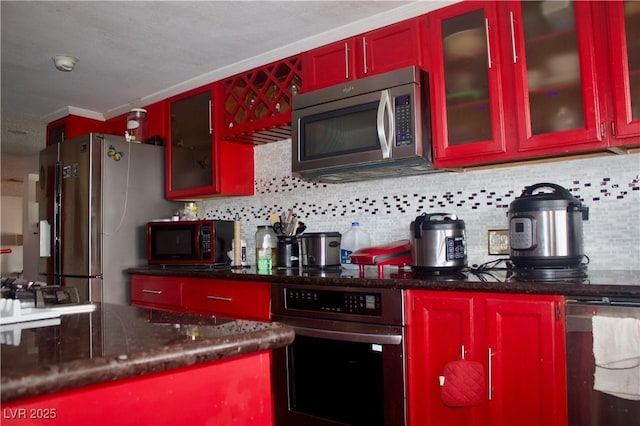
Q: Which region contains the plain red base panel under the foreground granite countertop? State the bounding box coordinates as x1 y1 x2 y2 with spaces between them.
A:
2 352 273 426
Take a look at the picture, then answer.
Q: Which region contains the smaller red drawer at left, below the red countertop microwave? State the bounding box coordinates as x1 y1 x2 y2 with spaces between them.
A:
131 275 183 311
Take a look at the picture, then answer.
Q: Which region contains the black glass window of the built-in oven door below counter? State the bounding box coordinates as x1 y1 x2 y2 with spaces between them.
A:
288 336 384 426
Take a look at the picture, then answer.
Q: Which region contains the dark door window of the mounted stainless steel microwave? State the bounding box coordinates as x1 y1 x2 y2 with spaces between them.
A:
300 101 380 161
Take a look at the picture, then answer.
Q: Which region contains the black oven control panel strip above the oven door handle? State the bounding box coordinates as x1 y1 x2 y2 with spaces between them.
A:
285 288 382 316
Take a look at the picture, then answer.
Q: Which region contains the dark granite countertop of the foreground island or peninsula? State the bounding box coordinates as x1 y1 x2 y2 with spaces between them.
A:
0 304 294 402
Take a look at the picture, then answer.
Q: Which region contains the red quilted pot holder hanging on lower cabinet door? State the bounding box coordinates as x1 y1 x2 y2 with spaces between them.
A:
440 359 487 407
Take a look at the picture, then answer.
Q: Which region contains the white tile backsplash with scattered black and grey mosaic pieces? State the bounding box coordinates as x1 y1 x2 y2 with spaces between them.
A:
199 140 640 270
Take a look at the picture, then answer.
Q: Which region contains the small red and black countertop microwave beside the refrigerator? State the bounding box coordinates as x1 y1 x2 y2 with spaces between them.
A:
147 219 233 266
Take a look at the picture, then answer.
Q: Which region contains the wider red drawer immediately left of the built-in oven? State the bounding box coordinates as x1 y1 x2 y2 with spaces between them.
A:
182 278 271 321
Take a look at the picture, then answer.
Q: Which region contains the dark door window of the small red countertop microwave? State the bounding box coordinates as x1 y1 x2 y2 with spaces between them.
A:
150 225 196 260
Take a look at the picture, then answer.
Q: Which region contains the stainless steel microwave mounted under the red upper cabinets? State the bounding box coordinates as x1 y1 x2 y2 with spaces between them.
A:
292 67 435 182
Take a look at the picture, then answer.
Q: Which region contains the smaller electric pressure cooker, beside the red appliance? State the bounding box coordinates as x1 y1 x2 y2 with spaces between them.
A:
410 213 467 272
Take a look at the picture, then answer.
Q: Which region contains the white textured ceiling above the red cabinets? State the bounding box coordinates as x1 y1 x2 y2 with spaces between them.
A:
0 0 451 155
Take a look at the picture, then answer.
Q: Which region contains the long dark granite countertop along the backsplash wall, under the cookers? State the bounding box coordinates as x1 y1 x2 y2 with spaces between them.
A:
128 266 640 298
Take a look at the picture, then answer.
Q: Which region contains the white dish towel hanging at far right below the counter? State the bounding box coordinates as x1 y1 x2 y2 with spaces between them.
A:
592 315 640 400
